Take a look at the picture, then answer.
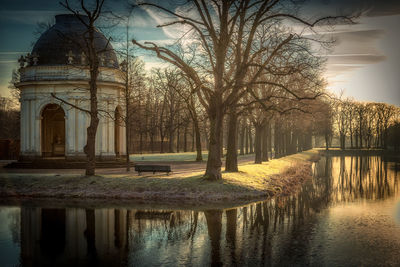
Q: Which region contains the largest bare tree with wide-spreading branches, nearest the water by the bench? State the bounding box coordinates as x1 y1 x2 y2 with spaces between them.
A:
132 0 354 180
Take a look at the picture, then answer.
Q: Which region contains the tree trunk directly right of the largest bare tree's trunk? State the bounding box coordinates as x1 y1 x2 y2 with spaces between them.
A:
225 110 238 172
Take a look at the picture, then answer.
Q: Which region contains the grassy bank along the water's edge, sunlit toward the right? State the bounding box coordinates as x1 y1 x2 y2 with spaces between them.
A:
0 150 318 203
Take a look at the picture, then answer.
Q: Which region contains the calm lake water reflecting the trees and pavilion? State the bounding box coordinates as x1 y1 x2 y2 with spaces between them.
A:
0 156 400 266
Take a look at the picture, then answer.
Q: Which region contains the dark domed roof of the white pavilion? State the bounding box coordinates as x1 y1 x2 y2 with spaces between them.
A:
31 14 118 68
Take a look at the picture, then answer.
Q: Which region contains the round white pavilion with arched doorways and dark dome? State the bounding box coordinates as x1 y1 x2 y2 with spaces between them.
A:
17 14 126 160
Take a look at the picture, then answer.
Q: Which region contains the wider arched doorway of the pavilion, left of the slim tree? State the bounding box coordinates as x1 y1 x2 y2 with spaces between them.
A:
42 104 65 157
